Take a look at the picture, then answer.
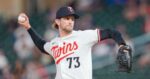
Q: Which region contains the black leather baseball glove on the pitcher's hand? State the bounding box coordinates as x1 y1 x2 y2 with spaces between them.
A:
117 45 132 73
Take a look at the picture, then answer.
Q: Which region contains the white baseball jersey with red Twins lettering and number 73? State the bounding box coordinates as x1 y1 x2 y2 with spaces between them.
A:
44 29 100 79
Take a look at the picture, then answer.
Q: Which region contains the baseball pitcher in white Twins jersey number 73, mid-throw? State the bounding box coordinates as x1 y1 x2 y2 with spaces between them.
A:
18 6 131 79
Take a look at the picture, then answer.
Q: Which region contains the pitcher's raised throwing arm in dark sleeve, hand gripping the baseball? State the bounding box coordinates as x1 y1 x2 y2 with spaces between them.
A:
18 13 48 54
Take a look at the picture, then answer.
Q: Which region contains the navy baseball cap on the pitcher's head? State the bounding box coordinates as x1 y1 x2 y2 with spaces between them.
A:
56 6 79 19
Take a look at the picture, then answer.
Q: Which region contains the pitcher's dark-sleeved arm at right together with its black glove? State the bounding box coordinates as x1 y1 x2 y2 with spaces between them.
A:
100 29 132 73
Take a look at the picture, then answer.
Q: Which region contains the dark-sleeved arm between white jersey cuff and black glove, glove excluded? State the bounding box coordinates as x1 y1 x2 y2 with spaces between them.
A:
99 29 126 46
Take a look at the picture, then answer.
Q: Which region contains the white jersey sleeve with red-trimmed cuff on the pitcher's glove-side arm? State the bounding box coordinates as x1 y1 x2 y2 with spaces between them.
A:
81 29 100 45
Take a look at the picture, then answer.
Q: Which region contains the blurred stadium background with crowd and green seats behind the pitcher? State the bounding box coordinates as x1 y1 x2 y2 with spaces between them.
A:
0 0 150 79
